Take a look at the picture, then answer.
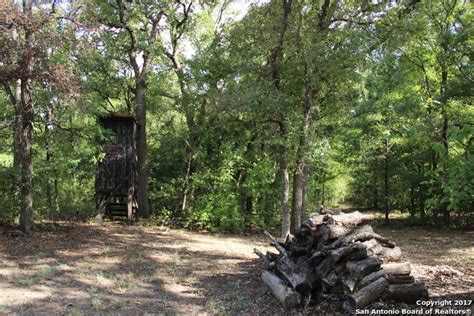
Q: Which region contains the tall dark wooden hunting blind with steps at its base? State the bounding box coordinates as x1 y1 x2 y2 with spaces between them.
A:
95 114 137 220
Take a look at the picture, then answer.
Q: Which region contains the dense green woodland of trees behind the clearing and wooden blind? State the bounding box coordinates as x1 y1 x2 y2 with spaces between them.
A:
0 0 474 235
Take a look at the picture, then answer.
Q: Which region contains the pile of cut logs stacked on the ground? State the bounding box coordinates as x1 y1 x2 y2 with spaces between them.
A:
255 212 428 312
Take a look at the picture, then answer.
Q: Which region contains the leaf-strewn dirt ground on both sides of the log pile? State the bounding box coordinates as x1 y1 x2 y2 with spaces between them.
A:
0 223 474 315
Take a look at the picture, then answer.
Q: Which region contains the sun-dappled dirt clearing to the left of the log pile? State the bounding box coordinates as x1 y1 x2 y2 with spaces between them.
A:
0 223 271 315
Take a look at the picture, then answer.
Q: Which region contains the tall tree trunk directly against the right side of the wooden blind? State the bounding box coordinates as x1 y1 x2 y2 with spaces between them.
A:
135 78 150 218
